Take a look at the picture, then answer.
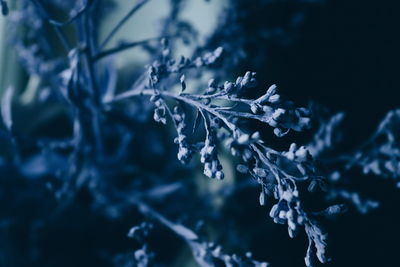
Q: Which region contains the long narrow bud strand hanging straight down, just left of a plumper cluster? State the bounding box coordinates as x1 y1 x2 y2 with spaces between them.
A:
173 106 193 164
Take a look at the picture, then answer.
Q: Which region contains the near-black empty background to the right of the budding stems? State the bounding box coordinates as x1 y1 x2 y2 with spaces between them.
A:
236 0 400 266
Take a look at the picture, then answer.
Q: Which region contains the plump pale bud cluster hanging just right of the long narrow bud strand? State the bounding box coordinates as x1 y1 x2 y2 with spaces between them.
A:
200 134 224 180
